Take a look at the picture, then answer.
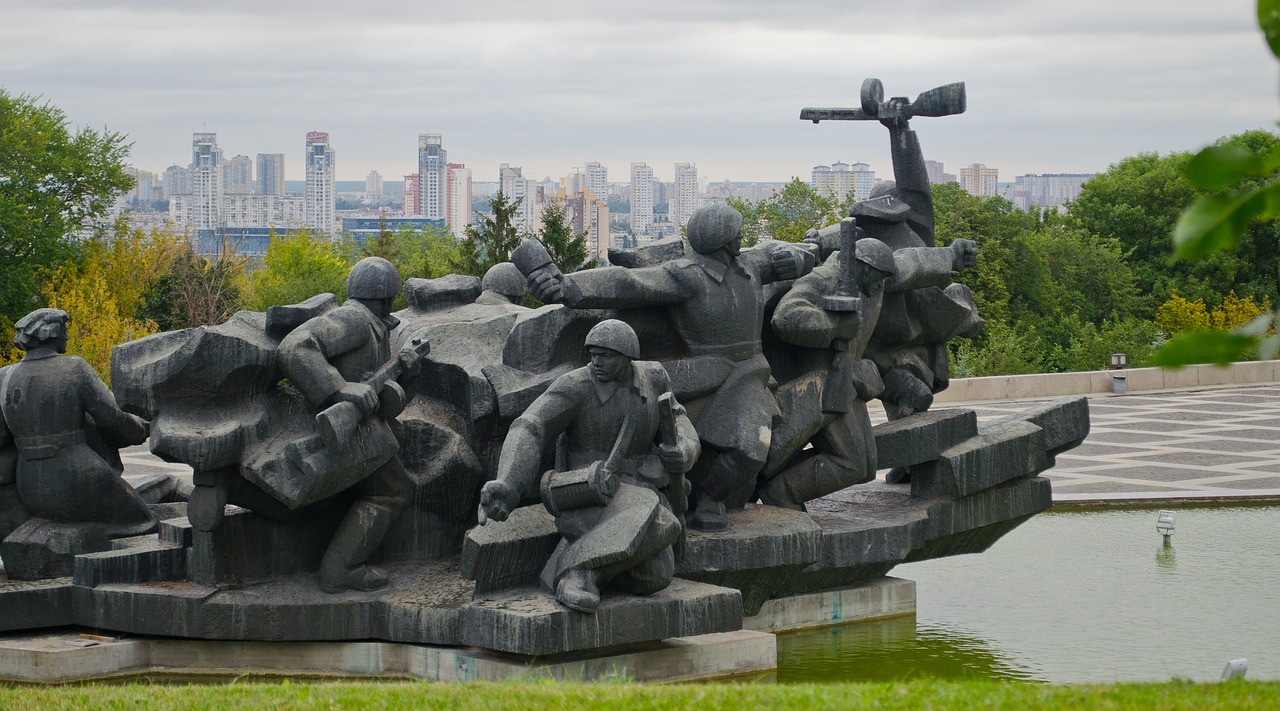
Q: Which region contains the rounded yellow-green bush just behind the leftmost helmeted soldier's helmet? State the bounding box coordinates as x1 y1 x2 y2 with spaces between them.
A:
241 229 352 311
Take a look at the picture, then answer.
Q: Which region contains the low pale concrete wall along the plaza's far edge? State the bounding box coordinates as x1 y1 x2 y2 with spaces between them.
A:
934 360 1280 402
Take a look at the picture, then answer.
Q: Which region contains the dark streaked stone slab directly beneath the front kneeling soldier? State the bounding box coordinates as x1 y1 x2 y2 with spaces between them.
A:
461 578 742 656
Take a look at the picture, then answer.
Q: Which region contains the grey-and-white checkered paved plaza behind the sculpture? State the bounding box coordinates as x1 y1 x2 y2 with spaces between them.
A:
120 383 1280 503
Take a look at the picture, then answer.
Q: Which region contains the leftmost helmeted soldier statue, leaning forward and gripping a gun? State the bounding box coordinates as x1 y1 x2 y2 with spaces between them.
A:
276 256 408 592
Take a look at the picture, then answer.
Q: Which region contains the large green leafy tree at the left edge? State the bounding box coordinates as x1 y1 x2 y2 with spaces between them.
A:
0 88 133 320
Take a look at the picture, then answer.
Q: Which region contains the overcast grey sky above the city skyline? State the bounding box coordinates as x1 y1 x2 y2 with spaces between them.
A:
0 0 1280 181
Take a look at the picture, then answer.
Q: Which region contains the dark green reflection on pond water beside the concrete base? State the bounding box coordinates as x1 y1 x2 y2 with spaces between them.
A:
777 616 1037 683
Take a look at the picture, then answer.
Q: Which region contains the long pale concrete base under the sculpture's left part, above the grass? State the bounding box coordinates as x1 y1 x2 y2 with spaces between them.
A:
0 628 777 684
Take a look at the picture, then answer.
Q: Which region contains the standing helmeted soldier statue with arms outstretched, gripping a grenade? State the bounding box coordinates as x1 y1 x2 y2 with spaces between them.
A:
527 204 817 530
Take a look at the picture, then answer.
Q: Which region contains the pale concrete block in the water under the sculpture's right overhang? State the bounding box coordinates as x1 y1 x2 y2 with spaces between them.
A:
742 578 915 632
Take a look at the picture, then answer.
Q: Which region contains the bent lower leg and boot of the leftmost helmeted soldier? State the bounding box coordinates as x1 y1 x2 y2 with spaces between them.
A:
320 501 393 593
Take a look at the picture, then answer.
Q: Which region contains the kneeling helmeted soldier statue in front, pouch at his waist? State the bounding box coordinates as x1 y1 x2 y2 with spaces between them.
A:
480 319 700 612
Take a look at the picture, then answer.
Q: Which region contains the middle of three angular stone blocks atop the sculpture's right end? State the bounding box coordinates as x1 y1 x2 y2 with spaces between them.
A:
911 420 1048 497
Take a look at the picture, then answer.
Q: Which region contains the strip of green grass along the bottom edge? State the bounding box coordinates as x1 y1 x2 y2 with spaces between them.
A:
0 680 1280 711
